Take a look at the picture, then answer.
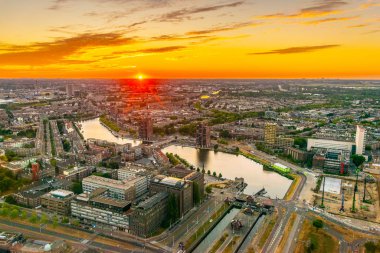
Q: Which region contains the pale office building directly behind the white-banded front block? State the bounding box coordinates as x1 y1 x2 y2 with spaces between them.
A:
82 175 136 201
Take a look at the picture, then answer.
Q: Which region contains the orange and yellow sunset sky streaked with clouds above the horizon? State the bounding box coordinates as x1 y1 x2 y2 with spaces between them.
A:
0 0 380 79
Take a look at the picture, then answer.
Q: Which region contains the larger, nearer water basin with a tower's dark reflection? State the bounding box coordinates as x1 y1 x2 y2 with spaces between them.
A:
162 145 292 198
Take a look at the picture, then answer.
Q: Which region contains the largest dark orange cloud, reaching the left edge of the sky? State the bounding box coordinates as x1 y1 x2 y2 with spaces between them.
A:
0 33 135 66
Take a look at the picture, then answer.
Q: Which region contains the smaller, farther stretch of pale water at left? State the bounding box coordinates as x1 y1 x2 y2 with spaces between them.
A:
78 118 141 146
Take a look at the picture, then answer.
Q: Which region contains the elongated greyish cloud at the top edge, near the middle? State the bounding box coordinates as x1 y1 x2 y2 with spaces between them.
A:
155 1 244 22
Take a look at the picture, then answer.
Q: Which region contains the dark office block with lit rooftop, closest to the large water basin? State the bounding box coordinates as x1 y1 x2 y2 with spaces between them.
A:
150 175 194 216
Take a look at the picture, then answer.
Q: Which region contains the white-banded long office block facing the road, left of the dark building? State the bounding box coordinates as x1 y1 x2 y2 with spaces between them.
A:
71 188 131 231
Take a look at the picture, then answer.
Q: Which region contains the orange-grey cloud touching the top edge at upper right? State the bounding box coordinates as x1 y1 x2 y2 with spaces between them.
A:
260 0 347 19
